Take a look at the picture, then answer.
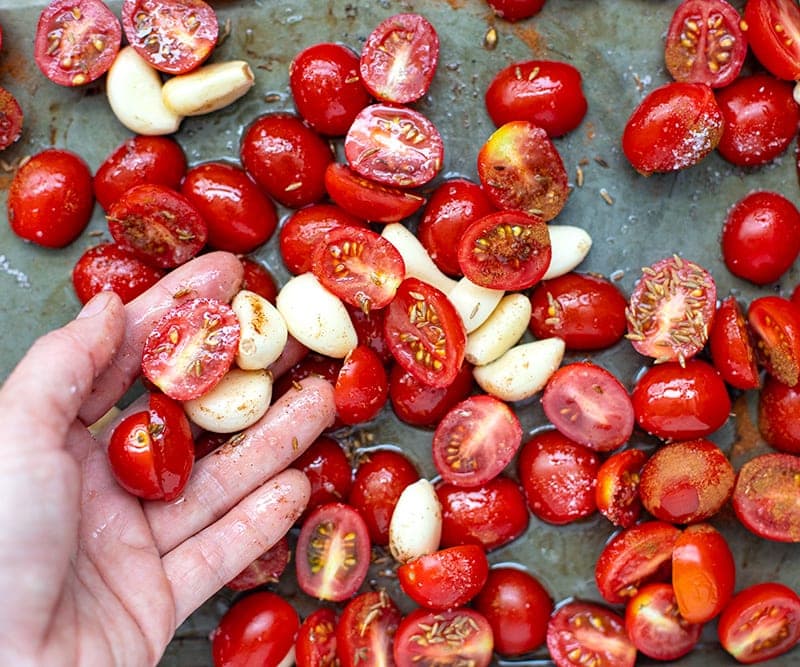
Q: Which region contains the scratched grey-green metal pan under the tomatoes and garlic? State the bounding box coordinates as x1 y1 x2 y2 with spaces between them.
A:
0 0 800 666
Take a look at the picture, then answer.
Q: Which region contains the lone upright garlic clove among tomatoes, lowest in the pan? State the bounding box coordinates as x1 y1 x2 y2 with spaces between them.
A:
389 478 442 563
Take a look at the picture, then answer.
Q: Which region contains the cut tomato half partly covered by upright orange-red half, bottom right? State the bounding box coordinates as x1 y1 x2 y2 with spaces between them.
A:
625 583 703 660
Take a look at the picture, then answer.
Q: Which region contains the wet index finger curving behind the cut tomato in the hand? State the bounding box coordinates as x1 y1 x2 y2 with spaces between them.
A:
80 252 242 424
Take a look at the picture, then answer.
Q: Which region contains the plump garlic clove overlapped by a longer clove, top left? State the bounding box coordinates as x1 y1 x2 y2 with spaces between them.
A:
106 46 183 135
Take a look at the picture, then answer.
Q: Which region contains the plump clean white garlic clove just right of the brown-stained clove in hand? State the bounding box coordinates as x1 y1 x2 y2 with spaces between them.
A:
275 273 358 359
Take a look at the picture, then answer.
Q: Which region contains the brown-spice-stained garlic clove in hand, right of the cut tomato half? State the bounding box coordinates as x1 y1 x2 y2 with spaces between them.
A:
231 290 289 370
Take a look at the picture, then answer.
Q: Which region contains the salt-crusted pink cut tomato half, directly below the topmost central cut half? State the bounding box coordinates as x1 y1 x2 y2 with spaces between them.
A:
344 104 444 188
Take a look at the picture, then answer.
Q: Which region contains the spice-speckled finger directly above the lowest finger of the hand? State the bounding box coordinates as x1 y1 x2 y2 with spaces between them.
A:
144 377 336 554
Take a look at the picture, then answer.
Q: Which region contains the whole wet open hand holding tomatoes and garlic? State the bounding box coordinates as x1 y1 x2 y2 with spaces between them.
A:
0 253 334 667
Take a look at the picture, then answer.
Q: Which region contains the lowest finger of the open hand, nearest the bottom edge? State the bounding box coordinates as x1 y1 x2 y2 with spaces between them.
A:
162 470 311 627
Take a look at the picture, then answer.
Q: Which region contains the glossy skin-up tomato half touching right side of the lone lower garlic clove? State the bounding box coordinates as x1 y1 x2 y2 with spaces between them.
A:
436 475 529 551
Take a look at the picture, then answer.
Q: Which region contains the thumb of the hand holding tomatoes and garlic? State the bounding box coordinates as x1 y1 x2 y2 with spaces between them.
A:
0 292 124 448
